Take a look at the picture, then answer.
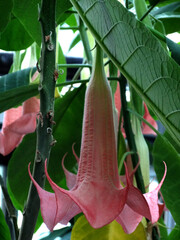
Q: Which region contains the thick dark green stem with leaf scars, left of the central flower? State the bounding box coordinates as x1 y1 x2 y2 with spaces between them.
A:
19 0 56 240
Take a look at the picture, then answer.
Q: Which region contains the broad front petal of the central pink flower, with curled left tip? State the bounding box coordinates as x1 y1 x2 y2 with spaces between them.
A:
45 159 127 228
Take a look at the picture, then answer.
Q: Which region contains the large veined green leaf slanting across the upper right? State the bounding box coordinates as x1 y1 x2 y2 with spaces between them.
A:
71 0 180 144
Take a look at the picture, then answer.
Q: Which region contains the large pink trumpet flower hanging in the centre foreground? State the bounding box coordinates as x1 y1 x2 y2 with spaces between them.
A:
28 47 151 231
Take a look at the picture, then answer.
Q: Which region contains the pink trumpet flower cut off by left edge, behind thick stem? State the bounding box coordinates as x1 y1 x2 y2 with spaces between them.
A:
0 97 39 156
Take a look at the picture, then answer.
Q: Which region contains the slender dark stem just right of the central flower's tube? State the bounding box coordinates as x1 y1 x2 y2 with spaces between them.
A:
119 74 145 193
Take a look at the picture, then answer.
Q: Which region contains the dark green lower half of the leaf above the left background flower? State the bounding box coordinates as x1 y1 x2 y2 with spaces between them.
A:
0 84 39 112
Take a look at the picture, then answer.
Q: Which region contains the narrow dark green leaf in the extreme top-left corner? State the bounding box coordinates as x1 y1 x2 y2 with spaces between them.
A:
0 0 13 32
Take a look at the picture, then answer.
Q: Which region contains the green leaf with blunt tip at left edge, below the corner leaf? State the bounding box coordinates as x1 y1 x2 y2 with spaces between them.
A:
0 18 33 51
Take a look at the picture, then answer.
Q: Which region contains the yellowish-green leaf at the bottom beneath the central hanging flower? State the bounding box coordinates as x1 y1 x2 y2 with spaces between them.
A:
71 216 147 240
